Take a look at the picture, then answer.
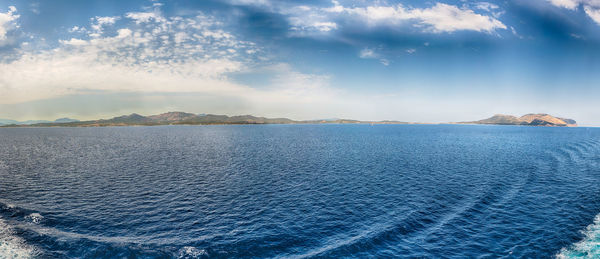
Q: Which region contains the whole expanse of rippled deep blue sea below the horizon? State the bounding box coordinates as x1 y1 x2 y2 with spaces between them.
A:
0 125 600 258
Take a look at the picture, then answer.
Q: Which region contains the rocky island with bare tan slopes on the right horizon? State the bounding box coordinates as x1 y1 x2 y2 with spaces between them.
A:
458 113 577 127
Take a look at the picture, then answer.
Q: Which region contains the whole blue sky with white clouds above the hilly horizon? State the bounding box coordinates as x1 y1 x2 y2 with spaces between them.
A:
0 0 600 126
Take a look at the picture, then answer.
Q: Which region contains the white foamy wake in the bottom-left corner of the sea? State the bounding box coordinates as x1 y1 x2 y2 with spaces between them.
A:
0 219 38 258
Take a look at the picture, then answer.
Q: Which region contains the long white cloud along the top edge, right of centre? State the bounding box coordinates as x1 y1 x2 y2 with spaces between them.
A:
232 0 507 36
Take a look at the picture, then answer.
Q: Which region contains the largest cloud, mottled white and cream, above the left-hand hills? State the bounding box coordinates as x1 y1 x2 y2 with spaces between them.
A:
0 4 356 121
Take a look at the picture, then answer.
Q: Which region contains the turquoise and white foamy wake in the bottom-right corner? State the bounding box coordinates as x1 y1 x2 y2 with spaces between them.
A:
556 214 600 259
